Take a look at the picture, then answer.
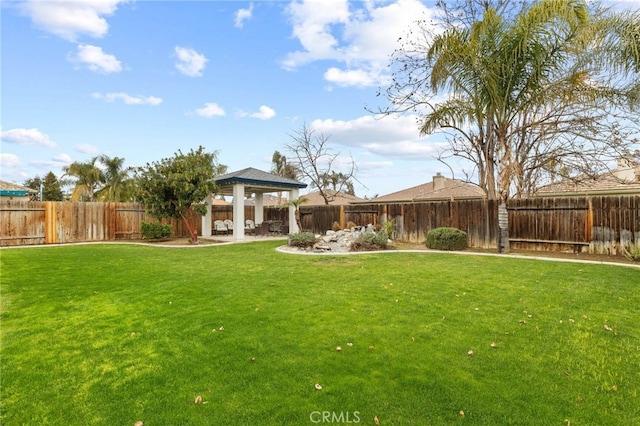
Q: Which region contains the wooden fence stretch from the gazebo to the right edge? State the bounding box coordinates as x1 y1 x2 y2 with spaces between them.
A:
214 195 640 255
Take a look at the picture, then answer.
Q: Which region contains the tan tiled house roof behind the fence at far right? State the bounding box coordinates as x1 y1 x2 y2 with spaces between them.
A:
535 159 640 197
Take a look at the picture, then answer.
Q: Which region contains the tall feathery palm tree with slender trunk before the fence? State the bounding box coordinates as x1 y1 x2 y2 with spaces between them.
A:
412 0 637 251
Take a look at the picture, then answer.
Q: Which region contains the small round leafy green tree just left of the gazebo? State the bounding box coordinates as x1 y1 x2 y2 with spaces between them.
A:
139 146 220 244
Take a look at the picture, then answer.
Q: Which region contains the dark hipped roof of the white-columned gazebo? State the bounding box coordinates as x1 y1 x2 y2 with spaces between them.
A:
214 167 307 195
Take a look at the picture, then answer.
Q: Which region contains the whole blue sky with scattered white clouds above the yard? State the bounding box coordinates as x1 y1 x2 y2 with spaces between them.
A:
0 0 640 197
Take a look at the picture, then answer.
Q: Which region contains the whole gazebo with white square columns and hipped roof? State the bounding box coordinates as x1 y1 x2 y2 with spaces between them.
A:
202 167 307 240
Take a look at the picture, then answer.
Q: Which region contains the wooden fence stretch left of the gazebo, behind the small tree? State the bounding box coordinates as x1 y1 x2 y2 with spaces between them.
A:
0 201 201 246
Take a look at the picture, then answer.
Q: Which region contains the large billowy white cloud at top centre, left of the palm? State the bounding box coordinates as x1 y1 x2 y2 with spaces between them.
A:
282 0 433 87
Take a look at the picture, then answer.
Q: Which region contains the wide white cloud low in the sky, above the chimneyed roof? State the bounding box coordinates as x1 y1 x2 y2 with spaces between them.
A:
310 115 443 160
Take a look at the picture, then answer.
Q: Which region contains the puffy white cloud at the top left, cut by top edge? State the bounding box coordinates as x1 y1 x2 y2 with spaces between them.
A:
18 0 128 42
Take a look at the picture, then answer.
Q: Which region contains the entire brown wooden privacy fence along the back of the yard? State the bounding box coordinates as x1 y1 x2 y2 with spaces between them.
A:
0 195 640 255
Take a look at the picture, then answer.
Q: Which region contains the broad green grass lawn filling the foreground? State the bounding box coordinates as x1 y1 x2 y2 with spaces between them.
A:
0 241 640 426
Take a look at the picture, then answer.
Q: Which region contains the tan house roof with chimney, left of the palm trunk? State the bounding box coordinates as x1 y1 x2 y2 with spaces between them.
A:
369 173 486 203
